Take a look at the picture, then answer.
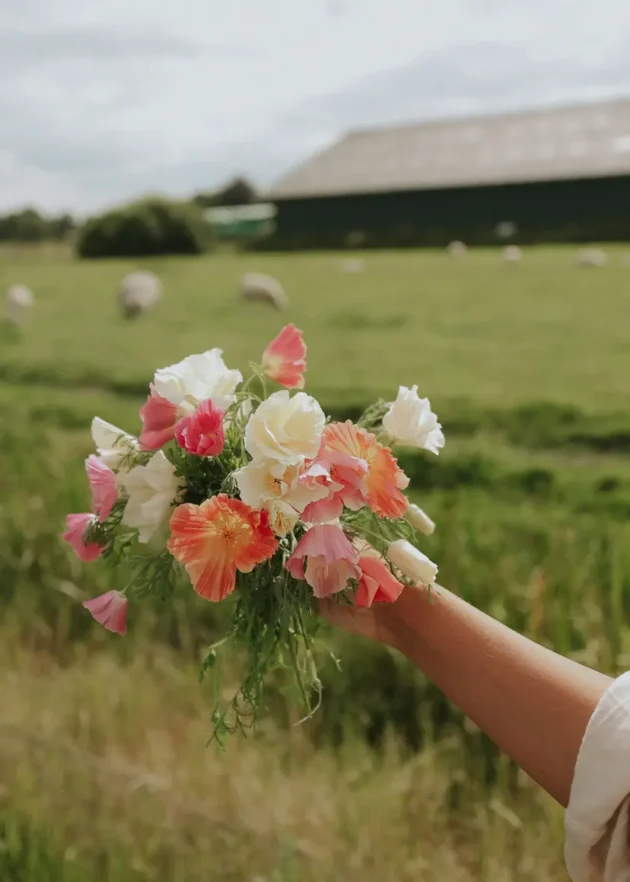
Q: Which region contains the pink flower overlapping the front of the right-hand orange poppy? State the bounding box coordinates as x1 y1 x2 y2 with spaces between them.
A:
302 447 368 524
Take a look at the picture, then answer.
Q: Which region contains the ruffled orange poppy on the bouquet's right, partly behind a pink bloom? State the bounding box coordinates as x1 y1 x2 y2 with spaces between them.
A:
322 420 409 518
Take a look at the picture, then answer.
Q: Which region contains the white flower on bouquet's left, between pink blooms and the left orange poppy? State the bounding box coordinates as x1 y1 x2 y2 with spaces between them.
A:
122 450 181 542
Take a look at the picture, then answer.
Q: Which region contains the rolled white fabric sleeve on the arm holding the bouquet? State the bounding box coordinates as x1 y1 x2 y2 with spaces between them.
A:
564 672 630 882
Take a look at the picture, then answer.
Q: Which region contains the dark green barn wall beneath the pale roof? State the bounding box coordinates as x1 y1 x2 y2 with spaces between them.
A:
274 177 630 248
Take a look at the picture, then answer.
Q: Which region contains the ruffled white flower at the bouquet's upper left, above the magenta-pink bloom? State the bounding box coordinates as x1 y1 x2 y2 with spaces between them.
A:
153 349 243 410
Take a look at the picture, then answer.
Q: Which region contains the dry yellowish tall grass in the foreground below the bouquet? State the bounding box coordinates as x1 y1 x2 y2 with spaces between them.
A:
0 645 562 882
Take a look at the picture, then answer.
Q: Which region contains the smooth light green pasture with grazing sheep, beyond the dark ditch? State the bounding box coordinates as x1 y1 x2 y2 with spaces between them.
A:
0 249 630 411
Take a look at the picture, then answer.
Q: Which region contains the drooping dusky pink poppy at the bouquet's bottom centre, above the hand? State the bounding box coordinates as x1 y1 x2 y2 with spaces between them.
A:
285 524 361 598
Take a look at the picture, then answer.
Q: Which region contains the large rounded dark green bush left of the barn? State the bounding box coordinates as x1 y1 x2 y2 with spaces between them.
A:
77 199 210 257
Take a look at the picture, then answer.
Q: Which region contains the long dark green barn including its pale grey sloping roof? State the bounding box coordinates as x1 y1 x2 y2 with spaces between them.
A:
266 100 630 248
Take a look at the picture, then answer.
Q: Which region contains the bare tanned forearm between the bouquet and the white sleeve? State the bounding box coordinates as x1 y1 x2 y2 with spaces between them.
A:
383 586 611 806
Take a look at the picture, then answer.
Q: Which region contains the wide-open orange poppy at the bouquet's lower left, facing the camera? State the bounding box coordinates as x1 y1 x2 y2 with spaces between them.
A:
167 493 278 601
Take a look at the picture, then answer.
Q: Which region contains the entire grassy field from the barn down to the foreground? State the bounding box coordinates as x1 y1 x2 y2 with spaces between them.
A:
0 242 630 882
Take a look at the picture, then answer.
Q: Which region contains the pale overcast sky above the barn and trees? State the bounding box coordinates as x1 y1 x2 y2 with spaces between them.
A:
0 0 630 214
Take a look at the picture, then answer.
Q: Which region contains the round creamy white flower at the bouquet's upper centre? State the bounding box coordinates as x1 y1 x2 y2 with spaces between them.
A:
245 389 325 465
